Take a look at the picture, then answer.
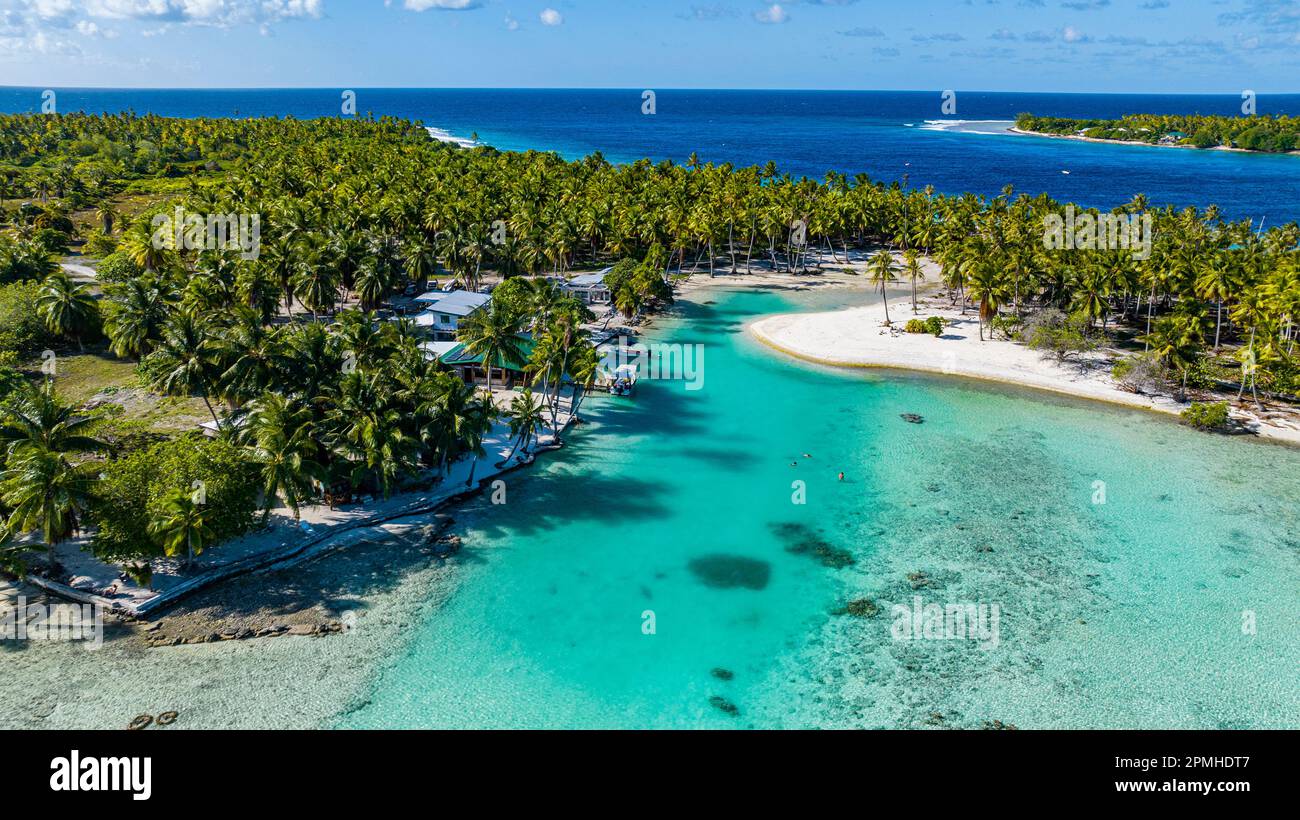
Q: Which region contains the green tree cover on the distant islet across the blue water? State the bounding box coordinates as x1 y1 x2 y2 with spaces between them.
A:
1015 114 1300 153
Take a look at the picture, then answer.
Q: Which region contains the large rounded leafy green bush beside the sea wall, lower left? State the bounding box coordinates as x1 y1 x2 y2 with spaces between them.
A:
91 434 260 560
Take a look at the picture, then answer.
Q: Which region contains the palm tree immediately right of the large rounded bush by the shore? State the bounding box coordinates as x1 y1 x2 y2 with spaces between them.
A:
241 392 324 524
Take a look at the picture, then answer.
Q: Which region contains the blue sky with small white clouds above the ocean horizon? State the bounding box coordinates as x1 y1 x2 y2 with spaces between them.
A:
0 0 1300 94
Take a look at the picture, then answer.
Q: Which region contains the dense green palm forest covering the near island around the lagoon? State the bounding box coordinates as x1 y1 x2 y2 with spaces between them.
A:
0 114 1300 579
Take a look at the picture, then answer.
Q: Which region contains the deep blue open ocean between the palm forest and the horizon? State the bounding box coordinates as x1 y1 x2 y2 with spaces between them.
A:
0 87 1300 226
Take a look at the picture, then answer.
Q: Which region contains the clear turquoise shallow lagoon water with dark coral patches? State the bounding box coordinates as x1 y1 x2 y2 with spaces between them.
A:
337 291 1300 728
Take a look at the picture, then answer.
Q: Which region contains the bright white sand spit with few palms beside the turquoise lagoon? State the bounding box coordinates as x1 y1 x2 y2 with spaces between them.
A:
748 292 1300 444
